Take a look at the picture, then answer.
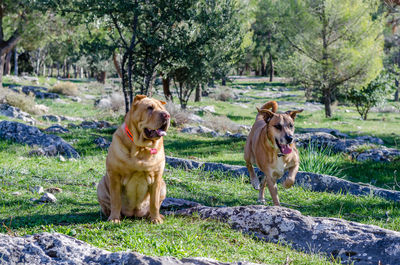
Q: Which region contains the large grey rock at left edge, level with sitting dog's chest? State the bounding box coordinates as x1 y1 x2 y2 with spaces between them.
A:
0 121 79 158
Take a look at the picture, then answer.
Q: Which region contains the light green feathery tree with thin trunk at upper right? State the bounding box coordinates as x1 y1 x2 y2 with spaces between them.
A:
280 0 383 117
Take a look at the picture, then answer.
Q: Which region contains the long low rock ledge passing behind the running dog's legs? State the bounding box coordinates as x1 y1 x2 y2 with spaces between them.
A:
166 156 400 202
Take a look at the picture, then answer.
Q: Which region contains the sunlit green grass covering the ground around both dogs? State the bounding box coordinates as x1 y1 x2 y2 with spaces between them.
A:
0 76 400 264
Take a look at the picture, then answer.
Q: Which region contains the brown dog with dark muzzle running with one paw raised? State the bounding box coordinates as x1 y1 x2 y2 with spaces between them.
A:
244 101 303 206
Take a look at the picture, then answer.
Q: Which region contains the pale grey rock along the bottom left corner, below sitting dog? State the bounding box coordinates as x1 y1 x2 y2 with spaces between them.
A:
0 233 258 265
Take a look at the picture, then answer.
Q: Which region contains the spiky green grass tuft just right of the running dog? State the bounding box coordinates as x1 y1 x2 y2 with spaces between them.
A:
299 143 342 177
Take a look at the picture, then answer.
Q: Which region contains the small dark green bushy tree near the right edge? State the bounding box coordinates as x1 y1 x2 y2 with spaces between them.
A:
347 71 395 120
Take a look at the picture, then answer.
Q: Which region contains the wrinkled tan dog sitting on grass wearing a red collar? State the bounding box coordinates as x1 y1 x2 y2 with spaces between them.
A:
97 95 170 223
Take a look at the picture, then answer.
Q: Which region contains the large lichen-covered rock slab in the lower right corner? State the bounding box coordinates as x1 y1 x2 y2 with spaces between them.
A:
175 205 400 264
